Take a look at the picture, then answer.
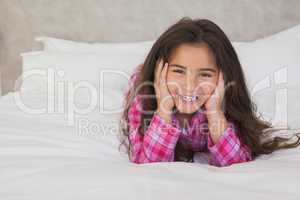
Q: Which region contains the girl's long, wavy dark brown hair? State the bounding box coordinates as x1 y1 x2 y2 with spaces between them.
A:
120 17 300 161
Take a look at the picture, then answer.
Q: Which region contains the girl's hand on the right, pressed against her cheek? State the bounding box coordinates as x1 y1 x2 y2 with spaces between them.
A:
205 71 225 114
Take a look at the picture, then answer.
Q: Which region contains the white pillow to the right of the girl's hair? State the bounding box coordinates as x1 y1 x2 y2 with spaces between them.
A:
236 25 300 128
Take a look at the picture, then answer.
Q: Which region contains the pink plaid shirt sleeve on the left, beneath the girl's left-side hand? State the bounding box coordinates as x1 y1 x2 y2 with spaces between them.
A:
128 65 180 164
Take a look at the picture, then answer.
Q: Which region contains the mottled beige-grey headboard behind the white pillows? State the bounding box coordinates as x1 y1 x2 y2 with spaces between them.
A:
0 0 300 94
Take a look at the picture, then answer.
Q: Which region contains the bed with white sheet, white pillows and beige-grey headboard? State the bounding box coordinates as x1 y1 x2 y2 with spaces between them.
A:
0 0 300 200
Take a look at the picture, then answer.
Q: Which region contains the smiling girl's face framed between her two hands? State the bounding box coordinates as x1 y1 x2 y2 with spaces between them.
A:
167 44 219 114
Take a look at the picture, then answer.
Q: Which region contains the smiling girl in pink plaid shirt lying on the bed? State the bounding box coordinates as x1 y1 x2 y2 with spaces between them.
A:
121 18 300 167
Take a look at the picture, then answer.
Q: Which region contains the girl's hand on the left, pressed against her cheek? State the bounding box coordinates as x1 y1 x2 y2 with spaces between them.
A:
154 59 175 116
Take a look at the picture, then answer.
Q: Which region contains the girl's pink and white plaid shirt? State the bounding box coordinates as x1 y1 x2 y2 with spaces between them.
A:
128 65 252 167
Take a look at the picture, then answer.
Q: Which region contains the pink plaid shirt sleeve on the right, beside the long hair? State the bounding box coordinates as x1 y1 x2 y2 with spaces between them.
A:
207 123 252 167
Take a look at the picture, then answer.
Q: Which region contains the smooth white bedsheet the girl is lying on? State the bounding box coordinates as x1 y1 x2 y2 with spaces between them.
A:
0 93 300 200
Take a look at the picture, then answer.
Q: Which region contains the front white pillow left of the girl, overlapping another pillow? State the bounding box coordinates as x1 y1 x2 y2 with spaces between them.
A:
20 51 146 117
